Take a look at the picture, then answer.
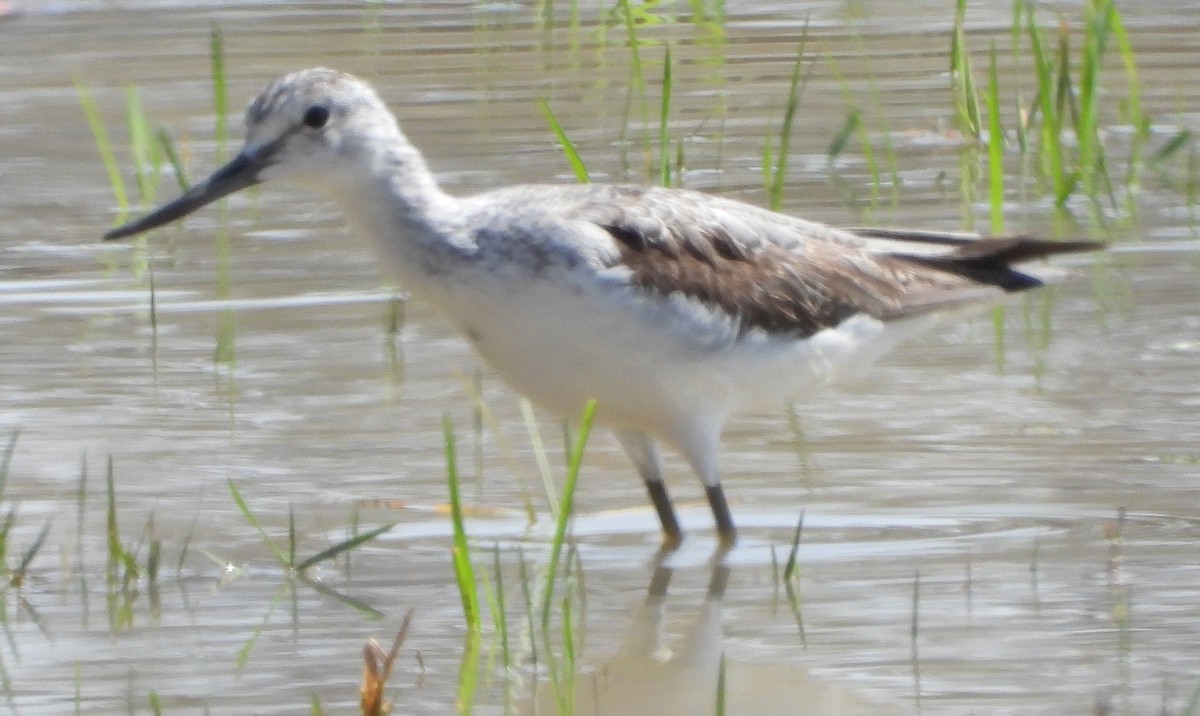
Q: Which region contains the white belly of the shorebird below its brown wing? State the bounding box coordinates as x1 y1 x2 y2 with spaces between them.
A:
417 265 934 441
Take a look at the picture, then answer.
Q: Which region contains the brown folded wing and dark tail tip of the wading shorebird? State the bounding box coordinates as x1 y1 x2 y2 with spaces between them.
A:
576 187 1099 337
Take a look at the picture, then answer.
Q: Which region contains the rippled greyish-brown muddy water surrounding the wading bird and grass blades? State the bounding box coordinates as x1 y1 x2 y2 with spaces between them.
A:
0 1 1200 714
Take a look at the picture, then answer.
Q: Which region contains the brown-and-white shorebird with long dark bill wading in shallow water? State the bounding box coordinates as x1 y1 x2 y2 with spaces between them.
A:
104 68 1099 546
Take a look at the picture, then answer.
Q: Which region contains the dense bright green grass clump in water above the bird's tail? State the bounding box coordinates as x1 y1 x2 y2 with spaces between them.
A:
950 0 1151 221
